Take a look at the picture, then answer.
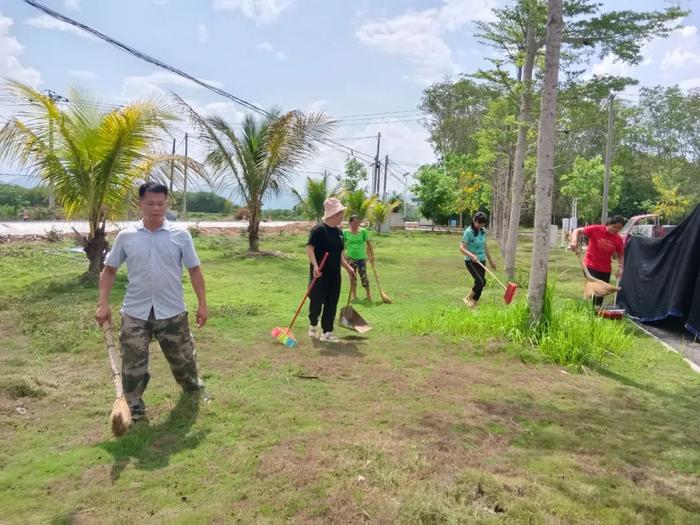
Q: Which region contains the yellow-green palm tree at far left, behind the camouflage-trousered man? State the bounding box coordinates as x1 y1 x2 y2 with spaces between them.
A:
0 81 202 278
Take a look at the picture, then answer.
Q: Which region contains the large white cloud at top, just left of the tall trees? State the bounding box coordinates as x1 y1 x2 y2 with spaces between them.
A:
355 0 497 84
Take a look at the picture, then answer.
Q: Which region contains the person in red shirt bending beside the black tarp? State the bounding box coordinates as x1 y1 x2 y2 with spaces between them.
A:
570 215 625 306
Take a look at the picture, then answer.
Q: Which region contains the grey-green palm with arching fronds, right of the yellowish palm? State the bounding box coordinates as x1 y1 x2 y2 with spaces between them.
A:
176 95 335 253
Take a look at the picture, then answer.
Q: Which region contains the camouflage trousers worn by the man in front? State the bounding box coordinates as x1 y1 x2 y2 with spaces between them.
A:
119 310 203 418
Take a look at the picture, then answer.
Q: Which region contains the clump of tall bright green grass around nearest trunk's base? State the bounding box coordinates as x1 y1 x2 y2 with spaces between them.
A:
408 281 632 370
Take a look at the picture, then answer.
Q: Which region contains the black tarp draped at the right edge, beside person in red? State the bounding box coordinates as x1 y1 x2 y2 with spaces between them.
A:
618 205 700 337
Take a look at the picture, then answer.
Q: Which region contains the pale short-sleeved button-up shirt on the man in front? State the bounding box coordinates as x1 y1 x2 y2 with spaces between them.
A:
105 220 200 320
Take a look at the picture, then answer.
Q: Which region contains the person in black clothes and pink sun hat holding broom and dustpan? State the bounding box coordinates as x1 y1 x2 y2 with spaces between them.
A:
306 197 355 343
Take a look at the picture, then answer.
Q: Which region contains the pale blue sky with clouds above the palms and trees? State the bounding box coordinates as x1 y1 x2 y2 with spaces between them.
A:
0 0 700 207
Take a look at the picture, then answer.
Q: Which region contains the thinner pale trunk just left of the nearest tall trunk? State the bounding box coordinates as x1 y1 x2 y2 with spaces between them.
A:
505 15 537 280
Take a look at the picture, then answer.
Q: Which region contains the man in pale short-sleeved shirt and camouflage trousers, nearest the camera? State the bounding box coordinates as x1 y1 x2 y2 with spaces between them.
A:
95 182 209 420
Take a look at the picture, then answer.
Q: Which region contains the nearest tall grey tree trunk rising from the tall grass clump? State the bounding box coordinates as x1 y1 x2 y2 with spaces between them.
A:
527 0 562 320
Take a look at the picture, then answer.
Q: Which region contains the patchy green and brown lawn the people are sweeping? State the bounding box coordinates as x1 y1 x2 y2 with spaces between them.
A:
0 233 700 524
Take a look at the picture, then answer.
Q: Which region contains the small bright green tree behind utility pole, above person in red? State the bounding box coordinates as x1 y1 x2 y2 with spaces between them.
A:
561 156 622 222
